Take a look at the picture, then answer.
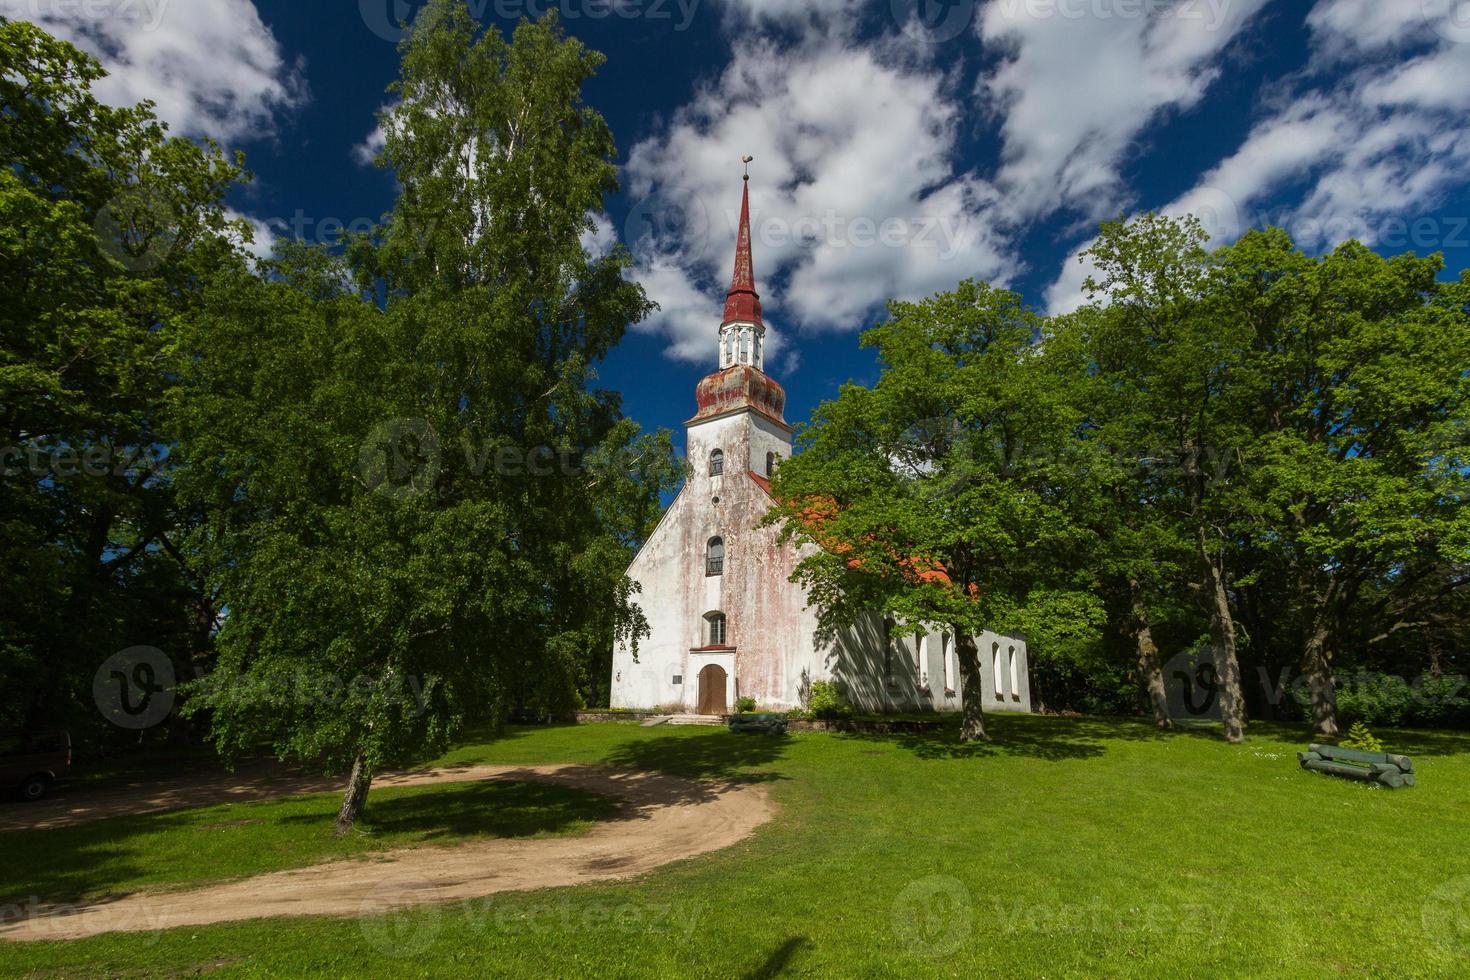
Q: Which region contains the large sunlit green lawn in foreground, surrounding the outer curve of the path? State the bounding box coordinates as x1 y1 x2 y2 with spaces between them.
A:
0 717 1470 977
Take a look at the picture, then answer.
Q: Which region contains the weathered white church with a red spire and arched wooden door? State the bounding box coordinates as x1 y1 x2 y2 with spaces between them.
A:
612 176 1030 714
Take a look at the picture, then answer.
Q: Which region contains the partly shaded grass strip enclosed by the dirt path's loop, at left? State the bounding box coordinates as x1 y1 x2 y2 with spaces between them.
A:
0 782 617 905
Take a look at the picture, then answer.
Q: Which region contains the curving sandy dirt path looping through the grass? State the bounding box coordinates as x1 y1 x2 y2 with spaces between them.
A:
0 765 775 940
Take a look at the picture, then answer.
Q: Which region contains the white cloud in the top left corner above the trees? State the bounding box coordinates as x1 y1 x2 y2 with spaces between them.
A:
0 0 306 143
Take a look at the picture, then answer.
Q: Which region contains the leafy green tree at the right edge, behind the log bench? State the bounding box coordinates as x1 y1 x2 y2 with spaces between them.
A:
1216 229 1470 736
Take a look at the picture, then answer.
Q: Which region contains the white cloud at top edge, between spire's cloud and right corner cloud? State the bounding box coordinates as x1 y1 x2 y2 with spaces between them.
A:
979 0 1269 220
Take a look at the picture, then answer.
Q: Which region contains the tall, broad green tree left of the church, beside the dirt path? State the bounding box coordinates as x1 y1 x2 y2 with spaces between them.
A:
178 0 676 832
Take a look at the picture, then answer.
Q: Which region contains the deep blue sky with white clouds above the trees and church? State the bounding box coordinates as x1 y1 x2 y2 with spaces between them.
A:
17 0 1470 443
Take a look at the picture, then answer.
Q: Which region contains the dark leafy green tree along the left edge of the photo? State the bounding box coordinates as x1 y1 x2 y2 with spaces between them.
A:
0 18 248 726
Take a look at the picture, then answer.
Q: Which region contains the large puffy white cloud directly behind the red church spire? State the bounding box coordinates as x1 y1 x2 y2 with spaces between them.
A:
626 37 1016 360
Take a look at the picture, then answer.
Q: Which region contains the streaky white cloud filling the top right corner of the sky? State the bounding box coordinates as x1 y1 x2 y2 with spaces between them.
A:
1047 0 1470 313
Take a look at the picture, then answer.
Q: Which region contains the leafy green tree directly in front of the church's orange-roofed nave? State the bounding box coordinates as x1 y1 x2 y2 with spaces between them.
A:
767 281 1101 741
